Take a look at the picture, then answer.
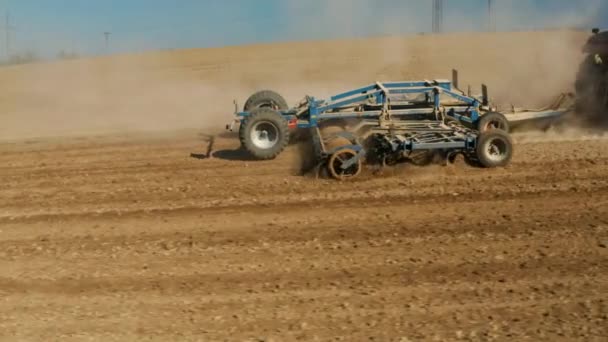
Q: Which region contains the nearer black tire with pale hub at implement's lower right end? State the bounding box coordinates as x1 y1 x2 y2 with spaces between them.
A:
476 130 513 168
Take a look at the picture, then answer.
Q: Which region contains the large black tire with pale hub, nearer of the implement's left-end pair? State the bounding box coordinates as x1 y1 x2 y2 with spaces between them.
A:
239 107 290 160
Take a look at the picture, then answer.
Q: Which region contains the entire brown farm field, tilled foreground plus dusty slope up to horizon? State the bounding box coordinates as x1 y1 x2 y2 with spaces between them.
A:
0 32 608 341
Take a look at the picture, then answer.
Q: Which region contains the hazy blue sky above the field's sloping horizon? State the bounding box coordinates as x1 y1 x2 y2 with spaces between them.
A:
0 0 608 56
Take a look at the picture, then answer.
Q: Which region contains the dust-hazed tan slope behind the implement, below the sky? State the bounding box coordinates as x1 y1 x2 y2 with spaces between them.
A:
0 31 588 139
